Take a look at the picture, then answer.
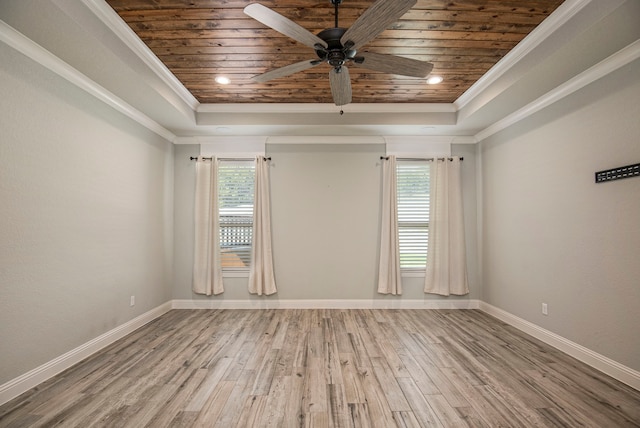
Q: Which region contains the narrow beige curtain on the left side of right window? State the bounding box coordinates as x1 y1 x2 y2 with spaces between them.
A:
378 156 402 295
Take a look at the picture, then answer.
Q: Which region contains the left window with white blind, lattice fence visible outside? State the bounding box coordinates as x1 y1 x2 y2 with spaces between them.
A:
218 160 255 269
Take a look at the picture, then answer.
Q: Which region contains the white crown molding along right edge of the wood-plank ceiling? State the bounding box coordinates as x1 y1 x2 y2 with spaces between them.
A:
453 0 592 111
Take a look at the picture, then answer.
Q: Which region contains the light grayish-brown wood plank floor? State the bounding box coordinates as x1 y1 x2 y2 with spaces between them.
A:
0 310 640 428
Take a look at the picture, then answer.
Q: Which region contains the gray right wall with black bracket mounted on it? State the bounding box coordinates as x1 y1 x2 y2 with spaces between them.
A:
481 60 640 370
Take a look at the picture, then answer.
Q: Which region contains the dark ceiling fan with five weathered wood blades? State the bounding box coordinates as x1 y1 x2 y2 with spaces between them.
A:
244 0 433 106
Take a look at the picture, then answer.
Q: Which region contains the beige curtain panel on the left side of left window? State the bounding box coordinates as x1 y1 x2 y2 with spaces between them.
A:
193 156 224 296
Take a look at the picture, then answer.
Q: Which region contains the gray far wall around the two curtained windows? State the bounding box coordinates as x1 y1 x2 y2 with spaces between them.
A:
173 144 481 301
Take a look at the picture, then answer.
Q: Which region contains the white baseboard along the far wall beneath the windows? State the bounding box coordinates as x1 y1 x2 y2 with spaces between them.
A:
171 298 480 309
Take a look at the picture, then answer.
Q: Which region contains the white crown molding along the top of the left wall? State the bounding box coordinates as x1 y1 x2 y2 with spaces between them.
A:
0 20 176 142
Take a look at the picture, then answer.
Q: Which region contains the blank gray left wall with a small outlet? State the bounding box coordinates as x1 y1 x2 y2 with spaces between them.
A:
0 44 173 384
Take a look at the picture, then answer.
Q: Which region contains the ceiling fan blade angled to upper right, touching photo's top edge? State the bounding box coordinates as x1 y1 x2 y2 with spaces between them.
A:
340 0 417 49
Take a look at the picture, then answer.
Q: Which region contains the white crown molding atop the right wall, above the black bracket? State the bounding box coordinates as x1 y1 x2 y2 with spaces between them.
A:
475 40 640 142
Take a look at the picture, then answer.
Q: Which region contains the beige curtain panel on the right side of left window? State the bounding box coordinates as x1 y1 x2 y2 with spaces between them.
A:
249 156 277 295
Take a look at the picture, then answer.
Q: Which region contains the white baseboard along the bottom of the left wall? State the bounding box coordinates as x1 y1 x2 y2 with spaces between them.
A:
0 302 171 405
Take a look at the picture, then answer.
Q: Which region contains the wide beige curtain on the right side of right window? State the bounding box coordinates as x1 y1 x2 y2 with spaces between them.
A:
424 157 469 296
